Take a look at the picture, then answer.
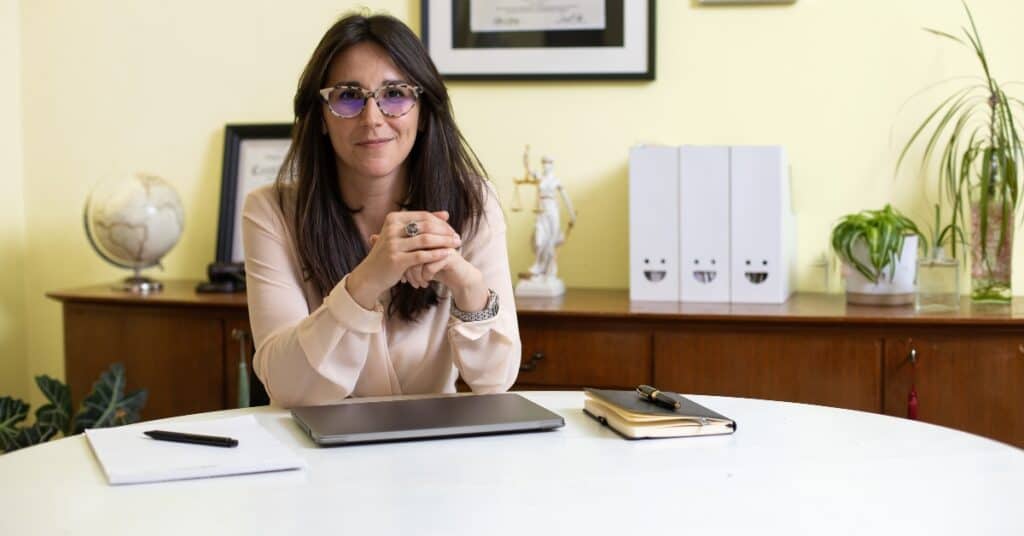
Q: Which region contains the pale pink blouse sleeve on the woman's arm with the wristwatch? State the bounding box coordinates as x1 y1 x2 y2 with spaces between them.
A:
449 189 522 393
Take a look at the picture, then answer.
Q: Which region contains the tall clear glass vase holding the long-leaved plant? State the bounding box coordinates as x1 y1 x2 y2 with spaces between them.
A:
971 198 1014 303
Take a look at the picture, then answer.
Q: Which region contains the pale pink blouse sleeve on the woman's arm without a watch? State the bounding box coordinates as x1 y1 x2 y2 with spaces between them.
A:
242 190 386 407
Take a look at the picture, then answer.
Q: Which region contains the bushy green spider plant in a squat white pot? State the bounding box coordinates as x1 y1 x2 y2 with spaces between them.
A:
831 205 927 305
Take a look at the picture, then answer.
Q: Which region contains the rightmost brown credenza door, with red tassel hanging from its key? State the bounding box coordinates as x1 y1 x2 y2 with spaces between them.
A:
885 336 1024 445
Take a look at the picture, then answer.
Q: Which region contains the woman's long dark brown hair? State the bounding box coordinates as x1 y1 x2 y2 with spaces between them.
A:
276 14 485 320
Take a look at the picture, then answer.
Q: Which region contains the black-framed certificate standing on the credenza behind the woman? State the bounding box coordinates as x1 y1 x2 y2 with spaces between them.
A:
216 123 292 262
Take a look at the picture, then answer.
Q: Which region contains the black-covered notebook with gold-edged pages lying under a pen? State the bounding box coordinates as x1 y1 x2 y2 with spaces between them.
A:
583 387 736 439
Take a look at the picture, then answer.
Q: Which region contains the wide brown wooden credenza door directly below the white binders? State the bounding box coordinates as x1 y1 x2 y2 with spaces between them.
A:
654 327 882 412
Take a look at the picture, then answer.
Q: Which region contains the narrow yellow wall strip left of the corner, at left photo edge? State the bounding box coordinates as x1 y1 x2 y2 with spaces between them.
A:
0 0 29 399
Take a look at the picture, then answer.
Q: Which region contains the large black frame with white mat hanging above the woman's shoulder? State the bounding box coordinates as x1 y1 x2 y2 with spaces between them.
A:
420 0 656 80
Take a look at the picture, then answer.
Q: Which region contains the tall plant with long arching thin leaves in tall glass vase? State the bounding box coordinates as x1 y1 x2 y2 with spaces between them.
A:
896 2 1024 302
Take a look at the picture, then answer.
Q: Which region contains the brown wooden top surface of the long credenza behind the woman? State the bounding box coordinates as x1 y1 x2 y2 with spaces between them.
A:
47 280 1024 327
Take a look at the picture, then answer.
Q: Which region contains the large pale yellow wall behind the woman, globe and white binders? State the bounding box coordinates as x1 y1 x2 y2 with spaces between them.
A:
8 0 1024 401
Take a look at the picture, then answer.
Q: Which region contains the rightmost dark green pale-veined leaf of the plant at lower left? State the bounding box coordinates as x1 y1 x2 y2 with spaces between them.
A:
74 363 148 434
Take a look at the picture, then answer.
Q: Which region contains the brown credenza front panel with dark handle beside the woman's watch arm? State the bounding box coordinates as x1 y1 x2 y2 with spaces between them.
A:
515 322 651 389
